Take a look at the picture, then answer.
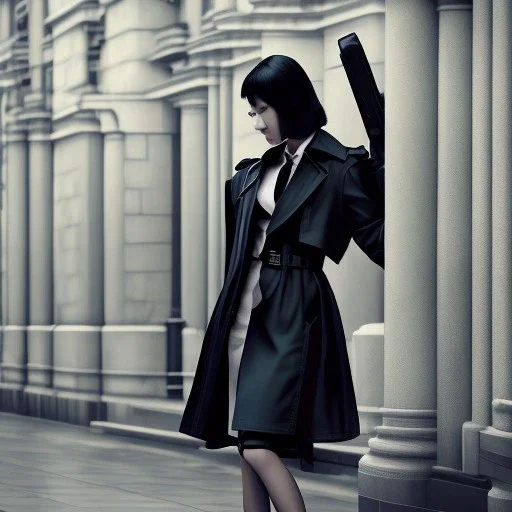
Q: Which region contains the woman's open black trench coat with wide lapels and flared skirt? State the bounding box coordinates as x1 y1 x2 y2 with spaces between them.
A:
179 130 384 464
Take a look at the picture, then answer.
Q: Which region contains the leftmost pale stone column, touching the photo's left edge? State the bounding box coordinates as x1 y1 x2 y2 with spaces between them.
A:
1 117 28 412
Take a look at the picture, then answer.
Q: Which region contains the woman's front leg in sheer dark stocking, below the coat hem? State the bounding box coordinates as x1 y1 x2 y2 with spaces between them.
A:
242 447 306 512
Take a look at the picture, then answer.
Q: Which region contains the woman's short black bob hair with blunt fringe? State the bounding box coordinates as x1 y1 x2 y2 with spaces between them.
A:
241 55 327 140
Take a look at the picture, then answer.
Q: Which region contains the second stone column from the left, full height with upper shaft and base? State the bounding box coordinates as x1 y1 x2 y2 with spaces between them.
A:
24 0 53 416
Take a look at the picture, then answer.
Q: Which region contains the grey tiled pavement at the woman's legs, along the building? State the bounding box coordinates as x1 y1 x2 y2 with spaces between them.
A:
0 413 357 512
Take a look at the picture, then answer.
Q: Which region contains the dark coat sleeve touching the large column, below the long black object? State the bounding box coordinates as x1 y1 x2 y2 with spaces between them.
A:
342 159 384 268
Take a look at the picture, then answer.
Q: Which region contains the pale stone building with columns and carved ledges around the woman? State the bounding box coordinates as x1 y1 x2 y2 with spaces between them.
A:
0 0 512 512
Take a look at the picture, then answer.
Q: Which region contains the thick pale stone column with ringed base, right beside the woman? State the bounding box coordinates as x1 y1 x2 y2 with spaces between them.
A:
359 0 438 512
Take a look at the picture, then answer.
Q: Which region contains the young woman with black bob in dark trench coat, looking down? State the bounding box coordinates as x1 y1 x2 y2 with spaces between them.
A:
180 55 384 512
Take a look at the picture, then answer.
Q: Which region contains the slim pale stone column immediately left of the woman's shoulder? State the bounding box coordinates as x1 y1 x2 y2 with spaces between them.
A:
207 75 224 317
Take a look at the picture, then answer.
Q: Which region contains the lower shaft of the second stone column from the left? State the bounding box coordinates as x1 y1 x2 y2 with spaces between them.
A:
27 121 53 394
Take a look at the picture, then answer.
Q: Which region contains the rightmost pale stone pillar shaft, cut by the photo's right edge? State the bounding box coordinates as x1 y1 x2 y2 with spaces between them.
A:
492 0 512 420
